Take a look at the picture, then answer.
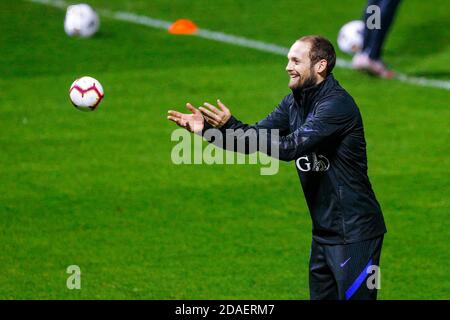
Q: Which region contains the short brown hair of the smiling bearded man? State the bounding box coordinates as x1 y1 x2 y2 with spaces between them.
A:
297 35 336 75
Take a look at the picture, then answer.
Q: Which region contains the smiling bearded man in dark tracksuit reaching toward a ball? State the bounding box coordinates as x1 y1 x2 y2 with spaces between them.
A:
168 36 386 299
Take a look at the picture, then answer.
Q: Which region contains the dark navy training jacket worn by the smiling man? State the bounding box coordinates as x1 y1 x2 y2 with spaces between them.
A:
203 74 386 244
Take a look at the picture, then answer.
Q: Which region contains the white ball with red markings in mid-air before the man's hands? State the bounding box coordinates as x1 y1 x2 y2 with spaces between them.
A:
69 77 104 111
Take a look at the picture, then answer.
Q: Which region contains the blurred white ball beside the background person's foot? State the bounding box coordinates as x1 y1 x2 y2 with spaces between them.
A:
338 20 365 54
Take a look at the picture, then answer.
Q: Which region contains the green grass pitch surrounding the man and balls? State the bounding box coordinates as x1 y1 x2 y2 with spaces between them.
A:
0 0 450 299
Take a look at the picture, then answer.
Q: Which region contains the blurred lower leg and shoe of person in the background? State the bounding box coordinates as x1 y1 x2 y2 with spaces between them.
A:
352 0 400 78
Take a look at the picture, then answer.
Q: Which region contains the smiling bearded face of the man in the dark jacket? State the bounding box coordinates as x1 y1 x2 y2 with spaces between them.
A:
286 41 318 89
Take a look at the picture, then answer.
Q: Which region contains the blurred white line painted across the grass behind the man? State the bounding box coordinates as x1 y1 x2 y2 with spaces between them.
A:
27 0 450 90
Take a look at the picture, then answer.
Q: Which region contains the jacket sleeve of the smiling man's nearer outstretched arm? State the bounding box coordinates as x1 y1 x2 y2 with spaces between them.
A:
202 96 354 161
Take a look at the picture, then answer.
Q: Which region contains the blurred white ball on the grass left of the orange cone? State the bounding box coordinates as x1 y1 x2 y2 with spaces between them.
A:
64 4 100 38
